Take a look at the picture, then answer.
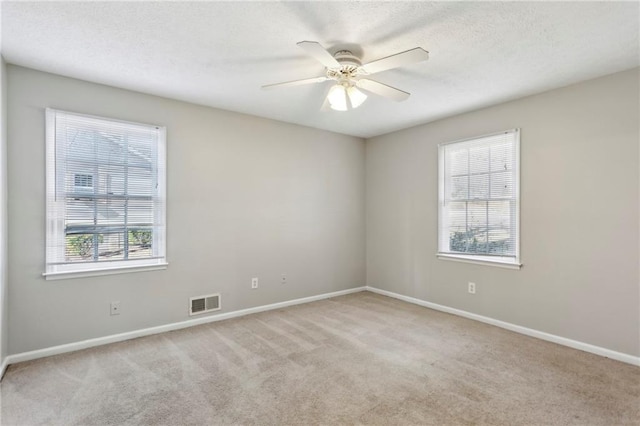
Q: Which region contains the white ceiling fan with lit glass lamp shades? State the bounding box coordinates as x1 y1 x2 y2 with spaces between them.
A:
262 41 429 111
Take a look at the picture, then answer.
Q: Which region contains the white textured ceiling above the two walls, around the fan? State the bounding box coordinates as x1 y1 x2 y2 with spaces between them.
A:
1 1 640 137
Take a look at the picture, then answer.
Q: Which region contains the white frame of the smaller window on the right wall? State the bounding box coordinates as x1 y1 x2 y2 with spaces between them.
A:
436 128 522 269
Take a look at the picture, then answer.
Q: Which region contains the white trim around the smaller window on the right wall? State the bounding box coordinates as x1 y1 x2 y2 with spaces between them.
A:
436 128 523 269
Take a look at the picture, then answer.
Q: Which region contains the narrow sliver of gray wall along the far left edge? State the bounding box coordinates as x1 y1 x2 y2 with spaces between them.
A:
0 56 9 365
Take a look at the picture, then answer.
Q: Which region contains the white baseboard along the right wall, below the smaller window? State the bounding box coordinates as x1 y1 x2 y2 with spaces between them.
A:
366 286 640 366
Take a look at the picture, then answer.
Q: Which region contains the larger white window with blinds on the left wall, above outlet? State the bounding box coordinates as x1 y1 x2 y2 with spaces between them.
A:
44 109 166 279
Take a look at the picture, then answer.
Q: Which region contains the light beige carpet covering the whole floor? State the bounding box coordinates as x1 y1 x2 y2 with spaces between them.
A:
1 292 640 425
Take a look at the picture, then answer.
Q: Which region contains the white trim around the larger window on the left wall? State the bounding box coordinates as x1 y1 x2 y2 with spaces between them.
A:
42 108 168 280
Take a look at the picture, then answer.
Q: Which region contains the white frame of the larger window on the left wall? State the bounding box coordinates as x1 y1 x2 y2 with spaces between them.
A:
42 108 168 280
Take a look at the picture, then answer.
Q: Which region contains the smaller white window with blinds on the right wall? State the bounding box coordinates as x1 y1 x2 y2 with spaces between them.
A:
438 129 520 267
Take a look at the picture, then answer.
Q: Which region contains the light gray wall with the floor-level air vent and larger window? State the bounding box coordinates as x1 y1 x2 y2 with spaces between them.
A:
7 65 365 354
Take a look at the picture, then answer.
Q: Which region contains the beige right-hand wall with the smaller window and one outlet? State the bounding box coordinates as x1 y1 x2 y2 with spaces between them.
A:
366 69 640 356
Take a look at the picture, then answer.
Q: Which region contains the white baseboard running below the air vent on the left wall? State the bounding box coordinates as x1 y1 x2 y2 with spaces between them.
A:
0 287 366 364
